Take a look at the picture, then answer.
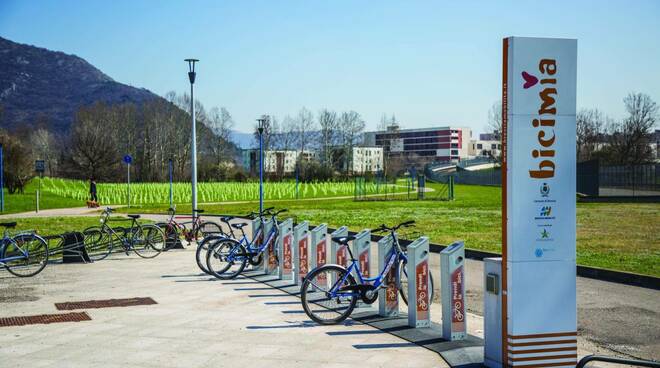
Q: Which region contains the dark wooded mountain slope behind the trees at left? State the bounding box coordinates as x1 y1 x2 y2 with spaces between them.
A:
0 37 159 132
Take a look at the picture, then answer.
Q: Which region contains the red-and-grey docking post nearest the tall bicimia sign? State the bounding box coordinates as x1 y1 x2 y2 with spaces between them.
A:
440 242 467 341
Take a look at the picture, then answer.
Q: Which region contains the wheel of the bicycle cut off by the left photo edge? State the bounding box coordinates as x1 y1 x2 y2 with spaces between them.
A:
3 234 48 277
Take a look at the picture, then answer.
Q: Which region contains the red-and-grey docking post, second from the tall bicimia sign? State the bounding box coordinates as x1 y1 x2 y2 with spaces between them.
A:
406 236 431 328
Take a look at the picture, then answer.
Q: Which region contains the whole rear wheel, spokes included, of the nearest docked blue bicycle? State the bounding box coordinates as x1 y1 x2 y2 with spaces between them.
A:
300 265 358 325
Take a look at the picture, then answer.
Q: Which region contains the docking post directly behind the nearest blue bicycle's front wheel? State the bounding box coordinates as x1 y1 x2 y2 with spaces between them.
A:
378 236 399 317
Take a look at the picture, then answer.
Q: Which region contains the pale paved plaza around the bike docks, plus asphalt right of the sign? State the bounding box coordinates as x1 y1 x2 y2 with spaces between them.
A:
0 216 660 367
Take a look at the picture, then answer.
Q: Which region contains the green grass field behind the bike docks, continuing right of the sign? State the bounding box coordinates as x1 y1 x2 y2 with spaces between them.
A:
2 178 660 276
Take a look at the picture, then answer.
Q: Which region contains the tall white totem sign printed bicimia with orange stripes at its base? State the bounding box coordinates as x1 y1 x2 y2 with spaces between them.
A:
502 37 577 367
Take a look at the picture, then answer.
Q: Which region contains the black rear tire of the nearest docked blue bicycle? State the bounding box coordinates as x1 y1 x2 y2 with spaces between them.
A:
300 264 358 325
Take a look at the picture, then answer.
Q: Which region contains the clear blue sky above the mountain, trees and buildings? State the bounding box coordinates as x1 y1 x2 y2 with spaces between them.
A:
0 0 660 132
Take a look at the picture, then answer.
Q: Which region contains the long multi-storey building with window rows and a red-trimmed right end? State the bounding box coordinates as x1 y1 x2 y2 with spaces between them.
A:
364 125 472 161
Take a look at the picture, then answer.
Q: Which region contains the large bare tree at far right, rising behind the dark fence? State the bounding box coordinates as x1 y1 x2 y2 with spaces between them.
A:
609 93 658 165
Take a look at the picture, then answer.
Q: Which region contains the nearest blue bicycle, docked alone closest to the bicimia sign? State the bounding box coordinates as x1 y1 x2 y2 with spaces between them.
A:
300 221 433 325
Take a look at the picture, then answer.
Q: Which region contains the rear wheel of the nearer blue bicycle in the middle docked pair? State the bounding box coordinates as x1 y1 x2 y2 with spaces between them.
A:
206 238 247 280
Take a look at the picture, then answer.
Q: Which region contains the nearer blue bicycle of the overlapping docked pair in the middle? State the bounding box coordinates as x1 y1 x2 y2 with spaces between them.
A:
206 208 286 280
